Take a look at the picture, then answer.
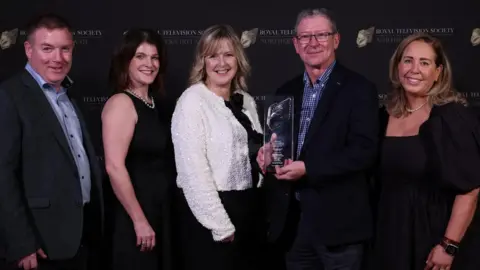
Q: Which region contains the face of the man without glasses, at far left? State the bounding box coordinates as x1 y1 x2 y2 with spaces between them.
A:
24 28 74 87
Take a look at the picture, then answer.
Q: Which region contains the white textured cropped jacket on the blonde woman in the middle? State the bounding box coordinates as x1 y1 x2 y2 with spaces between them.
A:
172 83 262 241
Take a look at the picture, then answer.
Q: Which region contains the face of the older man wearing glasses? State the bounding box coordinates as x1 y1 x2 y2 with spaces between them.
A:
293 15 340 68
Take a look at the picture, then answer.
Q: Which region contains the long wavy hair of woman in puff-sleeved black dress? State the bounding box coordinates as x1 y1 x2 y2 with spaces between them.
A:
386 32 467 117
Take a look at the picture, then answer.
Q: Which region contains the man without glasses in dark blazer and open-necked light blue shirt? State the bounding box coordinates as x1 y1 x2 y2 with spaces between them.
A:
0 14 103 270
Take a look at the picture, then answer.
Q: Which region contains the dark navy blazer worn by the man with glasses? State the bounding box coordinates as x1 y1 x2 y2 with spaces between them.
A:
265 62 379 246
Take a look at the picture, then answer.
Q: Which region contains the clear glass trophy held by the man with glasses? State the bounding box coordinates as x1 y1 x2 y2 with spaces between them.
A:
263 96 294 172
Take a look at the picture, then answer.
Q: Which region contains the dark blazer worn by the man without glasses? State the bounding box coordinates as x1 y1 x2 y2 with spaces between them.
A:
0 70 103 261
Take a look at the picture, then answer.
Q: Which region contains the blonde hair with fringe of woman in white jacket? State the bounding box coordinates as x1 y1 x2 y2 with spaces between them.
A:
189 24 250 92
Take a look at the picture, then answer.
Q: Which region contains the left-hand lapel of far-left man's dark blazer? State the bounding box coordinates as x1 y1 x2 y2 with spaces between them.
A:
22 71 77 170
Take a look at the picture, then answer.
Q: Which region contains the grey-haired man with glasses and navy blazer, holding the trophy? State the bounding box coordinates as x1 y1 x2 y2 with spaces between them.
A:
257 9 378 270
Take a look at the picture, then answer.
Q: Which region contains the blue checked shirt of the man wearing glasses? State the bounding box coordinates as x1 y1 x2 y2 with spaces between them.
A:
297 61 336 158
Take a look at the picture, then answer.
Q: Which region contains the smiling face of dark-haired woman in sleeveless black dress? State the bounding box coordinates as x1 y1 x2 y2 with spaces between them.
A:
128 43 160 87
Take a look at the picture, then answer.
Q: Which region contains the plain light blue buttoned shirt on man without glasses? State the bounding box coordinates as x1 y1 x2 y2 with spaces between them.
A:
25 64 91 204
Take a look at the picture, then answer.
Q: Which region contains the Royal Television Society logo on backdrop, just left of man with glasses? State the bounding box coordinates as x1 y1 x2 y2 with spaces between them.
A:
240 28 295 48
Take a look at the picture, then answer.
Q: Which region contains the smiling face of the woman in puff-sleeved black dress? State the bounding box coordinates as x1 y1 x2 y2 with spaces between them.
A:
398 41 443 96
